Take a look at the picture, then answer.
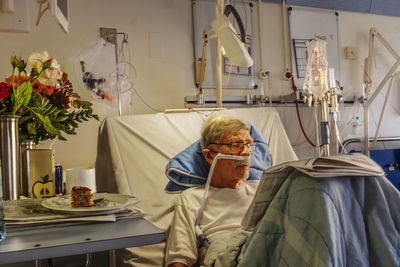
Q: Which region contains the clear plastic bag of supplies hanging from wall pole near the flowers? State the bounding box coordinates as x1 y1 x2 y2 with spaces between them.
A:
75 33 136 115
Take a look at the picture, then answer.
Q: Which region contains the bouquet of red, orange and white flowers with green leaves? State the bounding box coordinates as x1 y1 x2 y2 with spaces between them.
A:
0 51 98 144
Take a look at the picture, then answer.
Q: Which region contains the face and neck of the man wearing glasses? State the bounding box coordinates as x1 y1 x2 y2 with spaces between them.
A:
203 131 253 188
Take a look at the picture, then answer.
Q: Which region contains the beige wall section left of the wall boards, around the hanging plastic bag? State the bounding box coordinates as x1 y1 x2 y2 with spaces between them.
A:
0 0 195 168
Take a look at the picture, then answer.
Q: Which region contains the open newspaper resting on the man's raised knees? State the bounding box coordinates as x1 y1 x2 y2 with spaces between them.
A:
242 153 385 230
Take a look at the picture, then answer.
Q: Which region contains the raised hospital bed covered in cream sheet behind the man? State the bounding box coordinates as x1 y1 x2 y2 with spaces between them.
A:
96 107 297 266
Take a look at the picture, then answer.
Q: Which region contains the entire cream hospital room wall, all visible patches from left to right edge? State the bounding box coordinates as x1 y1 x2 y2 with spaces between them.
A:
0 0 400 168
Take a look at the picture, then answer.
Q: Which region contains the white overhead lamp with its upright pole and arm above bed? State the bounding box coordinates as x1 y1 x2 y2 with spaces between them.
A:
197 0 253 108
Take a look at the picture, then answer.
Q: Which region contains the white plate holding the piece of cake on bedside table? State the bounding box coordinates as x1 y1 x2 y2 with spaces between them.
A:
42 193 140 215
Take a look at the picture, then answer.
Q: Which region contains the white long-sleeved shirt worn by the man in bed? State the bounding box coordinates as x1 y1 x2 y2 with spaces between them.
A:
166 180 258 266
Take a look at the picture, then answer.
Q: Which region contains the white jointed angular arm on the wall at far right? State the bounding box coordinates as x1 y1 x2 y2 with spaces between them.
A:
363 28 400 156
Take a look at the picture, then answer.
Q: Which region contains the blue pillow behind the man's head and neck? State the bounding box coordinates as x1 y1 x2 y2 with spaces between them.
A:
165 123 271 193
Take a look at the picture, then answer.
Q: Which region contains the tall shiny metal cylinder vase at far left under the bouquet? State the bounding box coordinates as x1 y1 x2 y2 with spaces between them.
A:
0 115 21 200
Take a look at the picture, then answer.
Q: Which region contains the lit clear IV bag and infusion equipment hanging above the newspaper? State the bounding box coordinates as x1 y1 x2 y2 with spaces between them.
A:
303 37 340 156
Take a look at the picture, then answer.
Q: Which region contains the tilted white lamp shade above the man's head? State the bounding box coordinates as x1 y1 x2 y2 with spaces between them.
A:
211 15 253 67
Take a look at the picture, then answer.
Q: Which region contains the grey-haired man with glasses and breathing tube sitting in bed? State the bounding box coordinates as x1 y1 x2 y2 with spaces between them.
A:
166 115 257 267
